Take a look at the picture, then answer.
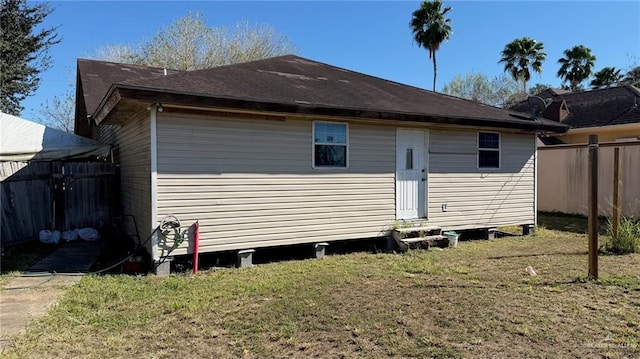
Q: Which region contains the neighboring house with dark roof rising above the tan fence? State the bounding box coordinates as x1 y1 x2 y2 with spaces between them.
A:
512 85 640 145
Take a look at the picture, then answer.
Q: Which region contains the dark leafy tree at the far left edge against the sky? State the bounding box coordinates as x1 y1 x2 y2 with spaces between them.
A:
0 0 60 115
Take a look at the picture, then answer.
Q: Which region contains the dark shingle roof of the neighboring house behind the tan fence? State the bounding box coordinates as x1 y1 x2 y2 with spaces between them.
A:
511 85 640 128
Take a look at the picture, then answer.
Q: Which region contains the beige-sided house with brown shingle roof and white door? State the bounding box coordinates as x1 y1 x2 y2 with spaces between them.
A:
76 55 567 272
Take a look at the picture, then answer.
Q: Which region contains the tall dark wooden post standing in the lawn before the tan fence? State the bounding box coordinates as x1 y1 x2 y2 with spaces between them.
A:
588 135 598 279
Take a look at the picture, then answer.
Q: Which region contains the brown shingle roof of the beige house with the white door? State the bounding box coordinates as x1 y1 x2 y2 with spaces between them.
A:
78 55 567 132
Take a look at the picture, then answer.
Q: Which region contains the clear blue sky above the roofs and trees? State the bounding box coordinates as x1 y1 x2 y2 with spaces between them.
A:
22 0 640 119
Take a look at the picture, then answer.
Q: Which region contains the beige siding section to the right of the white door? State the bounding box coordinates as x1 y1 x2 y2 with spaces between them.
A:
427 130 535 229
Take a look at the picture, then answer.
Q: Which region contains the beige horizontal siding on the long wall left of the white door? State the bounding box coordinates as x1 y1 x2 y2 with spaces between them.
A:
157 114 395 255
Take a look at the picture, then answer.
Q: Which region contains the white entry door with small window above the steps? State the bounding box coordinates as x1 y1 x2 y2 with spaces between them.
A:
396 129 427 219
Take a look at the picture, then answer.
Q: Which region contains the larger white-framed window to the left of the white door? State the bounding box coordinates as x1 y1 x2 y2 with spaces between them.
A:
313 122 348 168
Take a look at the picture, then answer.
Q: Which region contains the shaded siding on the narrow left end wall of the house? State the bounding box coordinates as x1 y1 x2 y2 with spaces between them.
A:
97 113 154 253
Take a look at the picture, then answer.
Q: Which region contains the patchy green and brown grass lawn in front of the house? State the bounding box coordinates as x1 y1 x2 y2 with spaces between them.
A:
2 218 640 358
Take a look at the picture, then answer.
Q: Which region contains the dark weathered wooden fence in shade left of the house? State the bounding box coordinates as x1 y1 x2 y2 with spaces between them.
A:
0 162 119 246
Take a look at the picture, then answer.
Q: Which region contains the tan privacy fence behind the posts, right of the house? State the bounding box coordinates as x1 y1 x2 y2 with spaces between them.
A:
538 142 640 218
